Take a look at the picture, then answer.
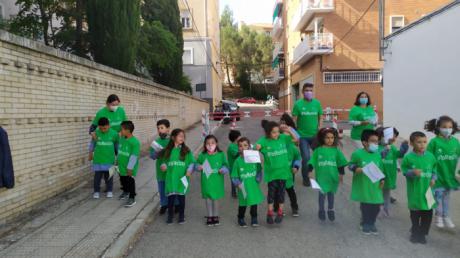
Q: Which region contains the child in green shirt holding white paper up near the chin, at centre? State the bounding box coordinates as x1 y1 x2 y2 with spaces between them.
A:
231 137 264 227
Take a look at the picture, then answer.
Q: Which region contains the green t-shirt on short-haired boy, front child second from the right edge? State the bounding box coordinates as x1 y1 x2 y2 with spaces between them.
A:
401 151 437 210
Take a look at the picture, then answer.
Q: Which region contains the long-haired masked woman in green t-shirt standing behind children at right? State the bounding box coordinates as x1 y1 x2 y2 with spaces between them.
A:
349 92 378 148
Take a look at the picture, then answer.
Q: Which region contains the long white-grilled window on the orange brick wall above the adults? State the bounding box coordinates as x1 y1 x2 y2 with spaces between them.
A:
323 71 382 84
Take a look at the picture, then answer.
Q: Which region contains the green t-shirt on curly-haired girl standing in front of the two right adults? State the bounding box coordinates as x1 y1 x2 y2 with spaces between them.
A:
308 146 348 193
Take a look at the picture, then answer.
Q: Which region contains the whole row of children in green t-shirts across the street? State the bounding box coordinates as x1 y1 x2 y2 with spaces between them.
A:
90 114 460 243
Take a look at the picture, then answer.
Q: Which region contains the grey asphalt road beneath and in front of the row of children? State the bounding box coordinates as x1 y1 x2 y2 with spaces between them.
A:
129 108 460 258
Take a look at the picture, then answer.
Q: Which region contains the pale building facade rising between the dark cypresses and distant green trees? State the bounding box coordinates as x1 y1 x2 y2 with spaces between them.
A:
178 0 223 107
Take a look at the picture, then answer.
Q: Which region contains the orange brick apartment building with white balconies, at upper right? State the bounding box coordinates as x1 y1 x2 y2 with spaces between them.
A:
272 0 451 119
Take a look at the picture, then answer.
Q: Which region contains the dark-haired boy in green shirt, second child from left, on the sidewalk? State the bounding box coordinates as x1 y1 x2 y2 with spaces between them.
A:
118 121 141 208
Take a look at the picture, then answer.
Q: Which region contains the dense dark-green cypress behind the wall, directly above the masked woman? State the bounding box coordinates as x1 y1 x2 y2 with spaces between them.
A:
86 0 140 73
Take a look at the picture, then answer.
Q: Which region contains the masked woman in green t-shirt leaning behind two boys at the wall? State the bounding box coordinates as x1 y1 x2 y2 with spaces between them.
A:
89 94 128 135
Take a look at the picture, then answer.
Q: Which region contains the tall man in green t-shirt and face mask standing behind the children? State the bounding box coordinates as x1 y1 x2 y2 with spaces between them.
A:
292 82 323 186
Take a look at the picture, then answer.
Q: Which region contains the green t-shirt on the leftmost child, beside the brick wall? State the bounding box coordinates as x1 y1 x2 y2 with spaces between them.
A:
93 129 119 165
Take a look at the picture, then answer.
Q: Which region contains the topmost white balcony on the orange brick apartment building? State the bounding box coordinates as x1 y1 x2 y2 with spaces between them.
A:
291 0 334 31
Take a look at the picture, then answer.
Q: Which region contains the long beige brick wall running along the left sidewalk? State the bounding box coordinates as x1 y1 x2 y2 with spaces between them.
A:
0 31 208 225
